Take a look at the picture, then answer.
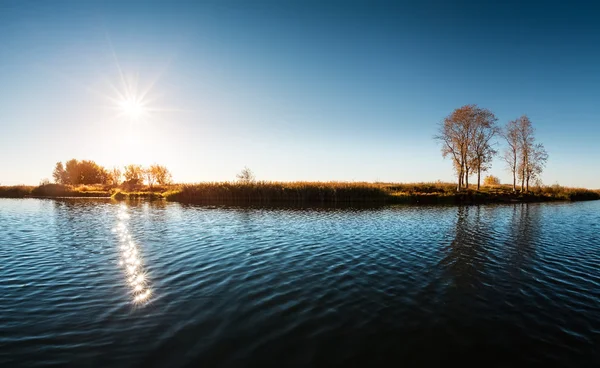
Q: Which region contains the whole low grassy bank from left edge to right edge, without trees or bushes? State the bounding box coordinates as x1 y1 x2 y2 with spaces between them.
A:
0 182 600 205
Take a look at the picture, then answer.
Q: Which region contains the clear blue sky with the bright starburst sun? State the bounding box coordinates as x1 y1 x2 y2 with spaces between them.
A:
0 0 600 188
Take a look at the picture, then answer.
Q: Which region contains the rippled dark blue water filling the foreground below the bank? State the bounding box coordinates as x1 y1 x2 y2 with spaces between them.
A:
0 199 600 367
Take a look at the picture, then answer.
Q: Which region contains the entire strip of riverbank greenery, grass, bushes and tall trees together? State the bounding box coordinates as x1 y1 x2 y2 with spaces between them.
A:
0 114 600 205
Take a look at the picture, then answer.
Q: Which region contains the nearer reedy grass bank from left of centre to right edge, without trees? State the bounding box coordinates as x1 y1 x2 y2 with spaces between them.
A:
163 182 600 204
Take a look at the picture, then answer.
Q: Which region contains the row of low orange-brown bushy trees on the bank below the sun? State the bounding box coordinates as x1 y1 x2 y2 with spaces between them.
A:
52 159 172 187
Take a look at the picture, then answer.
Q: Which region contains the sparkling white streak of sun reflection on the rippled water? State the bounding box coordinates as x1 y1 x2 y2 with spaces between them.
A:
113 205 152 303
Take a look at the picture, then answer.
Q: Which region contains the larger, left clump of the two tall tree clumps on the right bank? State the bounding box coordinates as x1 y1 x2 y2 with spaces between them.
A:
434 105 497 190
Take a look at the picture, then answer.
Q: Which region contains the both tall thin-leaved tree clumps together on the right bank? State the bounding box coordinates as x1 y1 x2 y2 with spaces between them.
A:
434 105 548 192
